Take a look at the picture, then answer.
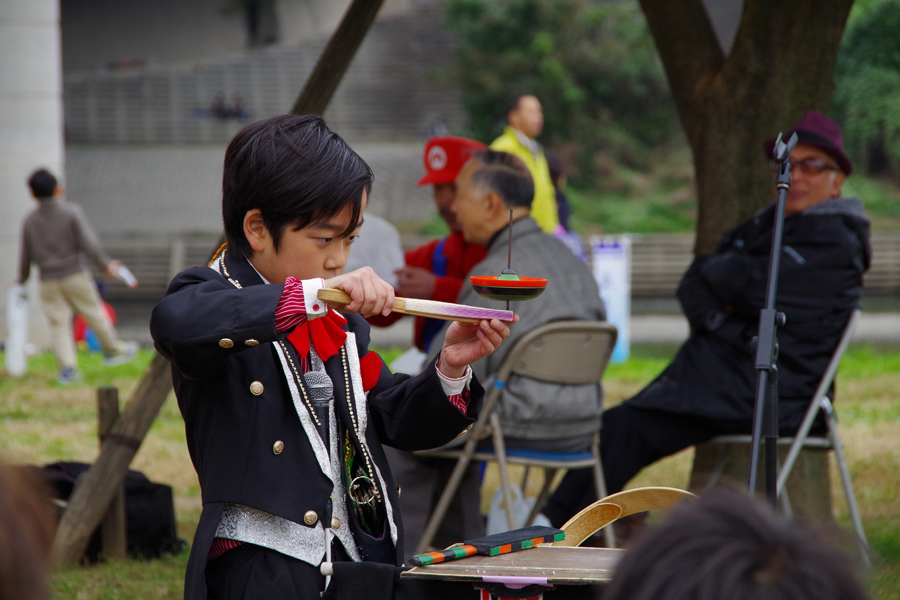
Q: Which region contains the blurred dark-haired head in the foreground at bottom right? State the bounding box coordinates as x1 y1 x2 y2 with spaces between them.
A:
603 492 868 600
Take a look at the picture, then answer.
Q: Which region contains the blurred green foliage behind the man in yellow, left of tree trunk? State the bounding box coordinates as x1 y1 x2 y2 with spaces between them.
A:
446 0 678 185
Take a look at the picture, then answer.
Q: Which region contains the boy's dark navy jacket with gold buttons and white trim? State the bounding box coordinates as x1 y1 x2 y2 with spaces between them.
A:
151 253 484 599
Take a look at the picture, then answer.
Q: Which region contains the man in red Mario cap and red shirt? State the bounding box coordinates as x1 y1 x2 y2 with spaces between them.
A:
369 135 486 352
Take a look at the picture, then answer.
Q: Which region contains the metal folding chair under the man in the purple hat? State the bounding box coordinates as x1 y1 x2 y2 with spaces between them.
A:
692 309 869 564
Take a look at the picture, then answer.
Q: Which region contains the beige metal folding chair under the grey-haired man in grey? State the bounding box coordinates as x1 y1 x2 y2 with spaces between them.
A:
416 321 617 554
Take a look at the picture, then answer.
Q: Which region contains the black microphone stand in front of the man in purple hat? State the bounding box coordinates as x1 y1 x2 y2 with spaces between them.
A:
747 133 797 506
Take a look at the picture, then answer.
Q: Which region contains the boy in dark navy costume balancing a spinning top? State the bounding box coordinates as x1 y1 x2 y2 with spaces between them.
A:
151 115 509 600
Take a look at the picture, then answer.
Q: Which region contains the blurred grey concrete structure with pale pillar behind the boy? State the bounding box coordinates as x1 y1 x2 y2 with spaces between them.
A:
0 0 465 344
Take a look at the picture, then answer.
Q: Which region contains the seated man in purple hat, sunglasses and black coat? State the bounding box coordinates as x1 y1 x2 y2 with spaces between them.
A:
544 110 871 526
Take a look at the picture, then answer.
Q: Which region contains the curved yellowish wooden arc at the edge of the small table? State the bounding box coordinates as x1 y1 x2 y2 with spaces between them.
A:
550 487 697 547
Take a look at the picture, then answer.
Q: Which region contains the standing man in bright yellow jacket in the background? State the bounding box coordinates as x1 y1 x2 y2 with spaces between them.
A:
491 94 559 233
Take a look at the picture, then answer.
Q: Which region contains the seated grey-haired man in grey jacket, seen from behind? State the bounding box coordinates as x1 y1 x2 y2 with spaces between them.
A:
389 150 606 552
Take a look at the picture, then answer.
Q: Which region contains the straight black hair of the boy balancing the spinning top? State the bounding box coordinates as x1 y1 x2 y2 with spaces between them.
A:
222 115 374 257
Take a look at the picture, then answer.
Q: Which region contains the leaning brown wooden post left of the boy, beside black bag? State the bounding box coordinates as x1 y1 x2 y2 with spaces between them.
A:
53 354 172 563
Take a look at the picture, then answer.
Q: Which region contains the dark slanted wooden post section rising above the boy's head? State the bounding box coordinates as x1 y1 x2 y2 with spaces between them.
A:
291 0 384 115
